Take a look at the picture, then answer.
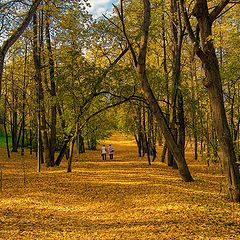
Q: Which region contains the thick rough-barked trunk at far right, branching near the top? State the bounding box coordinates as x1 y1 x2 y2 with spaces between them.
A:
181 0 240 202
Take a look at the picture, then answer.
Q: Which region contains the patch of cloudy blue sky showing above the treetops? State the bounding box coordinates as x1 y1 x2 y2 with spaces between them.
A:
89 0 118 17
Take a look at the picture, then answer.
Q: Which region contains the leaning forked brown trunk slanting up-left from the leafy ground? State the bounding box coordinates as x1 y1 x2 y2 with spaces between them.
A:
115 0 193 181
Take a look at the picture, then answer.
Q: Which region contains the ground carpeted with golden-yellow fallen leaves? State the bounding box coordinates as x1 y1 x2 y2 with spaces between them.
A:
0 136 240 240
